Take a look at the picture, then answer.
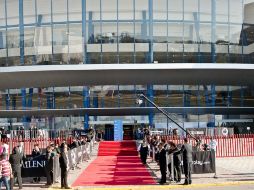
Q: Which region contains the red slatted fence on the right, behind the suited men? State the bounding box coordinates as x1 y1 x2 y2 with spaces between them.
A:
161 134 254 157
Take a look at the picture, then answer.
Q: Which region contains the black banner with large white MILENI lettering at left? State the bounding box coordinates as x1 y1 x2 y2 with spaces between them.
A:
21 155 46 178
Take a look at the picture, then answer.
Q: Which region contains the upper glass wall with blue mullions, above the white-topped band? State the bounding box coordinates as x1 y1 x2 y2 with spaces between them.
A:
0 0 254 66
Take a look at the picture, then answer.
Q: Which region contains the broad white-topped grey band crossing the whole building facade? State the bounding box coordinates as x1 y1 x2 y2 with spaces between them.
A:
0 63 254 89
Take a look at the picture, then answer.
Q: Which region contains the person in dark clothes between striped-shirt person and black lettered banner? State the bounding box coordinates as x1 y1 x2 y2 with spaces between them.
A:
9 147 22 189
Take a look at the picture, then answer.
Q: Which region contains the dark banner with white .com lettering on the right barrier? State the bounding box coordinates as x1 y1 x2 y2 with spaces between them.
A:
192 151 215 174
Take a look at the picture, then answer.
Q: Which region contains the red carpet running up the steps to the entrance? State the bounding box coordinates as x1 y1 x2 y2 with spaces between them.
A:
72 141 156 187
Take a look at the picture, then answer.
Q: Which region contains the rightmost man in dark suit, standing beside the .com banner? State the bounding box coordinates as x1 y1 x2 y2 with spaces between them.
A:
181 138 192 185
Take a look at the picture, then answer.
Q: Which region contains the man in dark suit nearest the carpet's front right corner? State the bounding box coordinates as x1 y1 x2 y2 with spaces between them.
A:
159 143 167 185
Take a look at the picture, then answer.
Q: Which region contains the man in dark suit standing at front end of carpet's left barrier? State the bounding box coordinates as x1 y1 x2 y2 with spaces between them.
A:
59 143 71 189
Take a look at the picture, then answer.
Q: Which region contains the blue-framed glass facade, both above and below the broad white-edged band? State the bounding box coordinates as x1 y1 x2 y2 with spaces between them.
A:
0 0 254 129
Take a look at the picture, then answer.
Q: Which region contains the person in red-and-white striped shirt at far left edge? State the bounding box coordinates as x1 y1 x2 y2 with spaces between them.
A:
0 154 12 190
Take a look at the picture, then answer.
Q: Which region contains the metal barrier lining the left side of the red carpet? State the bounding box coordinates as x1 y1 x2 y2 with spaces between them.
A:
53 140 94 182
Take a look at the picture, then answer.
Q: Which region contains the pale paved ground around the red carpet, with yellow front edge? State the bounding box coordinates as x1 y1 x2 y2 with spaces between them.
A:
15 144 254 190
